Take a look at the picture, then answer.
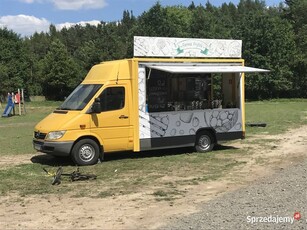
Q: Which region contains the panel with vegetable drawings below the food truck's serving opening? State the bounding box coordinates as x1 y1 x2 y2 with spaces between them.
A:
140 109 242 139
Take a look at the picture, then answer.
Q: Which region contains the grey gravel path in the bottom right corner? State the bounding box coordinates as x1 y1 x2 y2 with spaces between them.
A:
162 160 307 230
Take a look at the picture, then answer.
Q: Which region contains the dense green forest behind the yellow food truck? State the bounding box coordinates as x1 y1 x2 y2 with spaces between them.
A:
0 0 307 100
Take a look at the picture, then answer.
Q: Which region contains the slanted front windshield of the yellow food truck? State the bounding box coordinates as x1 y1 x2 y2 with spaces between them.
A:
58 84 102 110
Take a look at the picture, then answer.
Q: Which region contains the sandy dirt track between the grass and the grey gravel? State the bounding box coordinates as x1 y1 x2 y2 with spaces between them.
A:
0 126 307 229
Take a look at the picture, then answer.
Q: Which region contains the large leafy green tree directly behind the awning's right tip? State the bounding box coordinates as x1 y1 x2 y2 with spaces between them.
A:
238 10 296 99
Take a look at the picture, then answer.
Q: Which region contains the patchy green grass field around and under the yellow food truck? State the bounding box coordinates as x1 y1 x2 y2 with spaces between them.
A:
0 99 307 200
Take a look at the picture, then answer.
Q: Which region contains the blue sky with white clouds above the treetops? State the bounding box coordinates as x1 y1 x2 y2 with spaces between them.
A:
0 0 283 36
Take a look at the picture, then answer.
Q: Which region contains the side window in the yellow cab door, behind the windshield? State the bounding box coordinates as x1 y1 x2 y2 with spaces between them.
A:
100 87 125 112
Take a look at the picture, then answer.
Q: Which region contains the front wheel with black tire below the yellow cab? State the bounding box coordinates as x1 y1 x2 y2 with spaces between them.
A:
71 139 100 166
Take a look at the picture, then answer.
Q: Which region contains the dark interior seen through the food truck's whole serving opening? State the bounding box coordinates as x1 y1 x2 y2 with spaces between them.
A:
146 68 240 112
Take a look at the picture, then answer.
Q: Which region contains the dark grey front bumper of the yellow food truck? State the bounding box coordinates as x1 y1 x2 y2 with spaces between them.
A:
33 139 74 156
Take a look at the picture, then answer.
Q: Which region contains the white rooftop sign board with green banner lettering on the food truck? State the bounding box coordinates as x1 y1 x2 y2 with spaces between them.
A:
134 36 242 58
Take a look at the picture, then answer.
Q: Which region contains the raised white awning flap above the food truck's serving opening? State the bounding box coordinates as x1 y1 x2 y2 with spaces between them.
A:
146 65 270 74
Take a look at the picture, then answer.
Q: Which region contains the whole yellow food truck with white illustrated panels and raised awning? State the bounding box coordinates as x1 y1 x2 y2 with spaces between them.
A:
33 37 267 165
